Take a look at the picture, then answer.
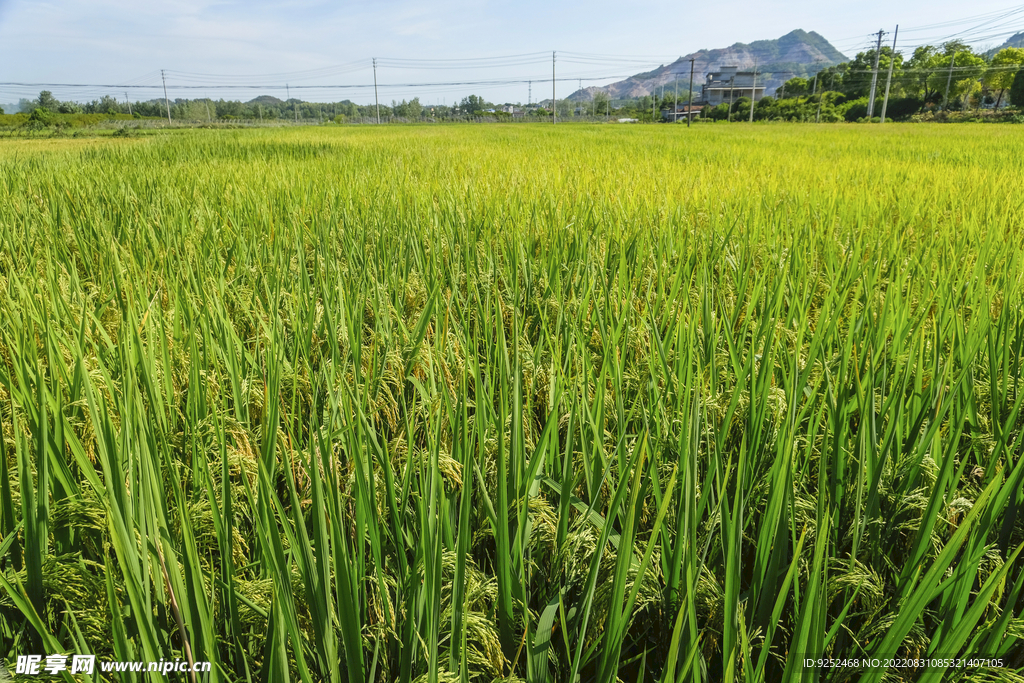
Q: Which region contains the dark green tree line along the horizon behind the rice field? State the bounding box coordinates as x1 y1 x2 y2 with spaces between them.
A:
8 40 1024 125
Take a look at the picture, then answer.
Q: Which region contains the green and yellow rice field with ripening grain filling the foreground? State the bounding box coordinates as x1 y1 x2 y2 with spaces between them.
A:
0 125 1024 683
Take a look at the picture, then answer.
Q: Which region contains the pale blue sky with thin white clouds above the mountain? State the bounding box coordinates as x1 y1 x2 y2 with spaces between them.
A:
0 0 1024 104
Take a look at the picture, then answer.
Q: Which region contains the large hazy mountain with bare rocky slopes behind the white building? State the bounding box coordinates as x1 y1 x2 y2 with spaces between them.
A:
568 29 848 100
